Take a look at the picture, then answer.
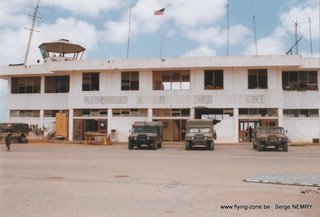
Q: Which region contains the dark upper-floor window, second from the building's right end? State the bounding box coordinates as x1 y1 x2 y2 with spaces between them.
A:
248 69 268 89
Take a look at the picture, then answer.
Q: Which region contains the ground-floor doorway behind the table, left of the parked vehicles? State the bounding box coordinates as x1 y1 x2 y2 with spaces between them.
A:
73 119 108 141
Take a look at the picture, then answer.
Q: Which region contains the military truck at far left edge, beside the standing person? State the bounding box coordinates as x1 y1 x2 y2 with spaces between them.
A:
0 123 29 143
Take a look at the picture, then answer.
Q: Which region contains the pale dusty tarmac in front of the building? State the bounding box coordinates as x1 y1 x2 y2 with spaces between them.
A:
0 143 320 217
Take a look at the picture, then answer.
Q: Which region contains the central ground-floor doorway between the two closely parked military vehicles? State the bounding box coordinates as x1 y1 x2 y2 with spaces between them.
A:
154 119 187 142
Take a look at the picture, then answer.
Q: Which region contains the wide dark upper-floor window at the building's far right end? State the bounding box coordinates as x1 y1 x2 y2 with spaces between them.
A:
282 71 318 91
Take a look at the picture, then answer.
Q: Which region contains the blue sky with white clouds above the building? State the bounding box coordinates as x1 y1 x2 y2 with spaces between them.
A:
0 0 320 121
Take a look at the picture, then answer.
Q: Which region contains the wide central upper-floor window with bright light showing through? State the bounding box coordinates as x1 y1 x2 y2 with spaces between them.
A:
153 71 190 90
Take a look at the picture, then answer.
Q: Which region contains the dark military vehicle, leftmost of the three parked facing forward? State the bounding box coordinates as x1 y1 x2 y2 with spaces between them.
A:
128 121 163 150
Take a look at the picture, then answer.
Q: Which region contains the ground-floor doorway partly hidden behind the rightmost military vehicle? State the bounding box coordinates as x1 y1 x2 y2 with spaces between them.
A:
239 119 278 142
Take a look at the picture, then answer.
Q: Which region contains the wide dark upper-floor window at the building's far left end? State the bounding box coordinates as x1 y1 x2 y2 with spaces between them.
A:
11 77 41 94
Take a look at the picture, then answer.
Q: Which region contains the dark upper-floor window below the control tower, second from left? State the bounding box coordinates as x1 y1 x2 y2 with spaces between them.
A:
45 76 69 93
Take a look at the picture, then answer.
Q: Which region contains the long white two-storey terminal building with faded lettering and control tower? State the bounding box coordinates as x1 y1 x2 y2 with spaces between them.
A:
0 40 320 143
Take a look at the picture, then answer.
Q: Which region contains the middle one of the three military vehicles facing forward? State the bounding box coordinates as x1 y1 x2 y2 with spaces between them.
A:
185 119 217 150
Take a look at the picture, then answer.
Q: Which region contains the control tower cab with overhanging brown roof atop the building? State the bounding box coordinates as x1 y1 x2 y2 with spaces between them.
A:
39 39 86 62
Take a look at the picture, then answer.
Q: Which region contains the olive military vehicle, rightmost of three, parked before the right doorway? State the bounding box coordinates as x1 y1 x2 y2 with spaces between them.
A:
252 127 288 151
